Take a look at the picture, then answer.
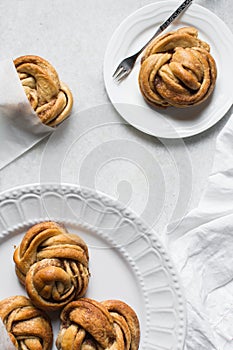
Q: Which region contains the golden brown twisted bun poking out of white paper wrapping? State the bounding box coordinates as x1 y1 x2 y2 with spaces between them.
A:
14 55 73 126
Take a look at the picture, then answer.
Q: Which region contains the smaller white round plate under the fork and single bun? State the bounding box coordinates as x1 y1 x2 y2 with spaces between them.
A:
104 1 233 138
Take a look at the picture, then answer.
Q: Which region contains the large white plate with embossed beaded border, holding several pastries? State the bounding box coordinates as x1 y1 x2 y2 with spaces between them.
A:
0 185 185 350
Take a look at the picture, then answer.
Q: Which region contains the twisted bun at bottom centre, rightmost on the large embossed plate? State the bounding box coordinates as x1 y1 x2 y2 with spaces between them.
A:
56 298 140 350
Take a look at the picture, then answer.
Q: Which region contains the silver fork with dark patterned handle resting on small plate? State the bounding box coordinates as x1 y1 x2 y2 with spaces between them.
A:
113 0 193 82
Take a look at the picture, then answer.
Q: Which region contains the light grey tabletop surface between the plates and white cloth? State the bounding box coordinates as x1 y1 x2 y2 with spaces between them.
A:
0 0 233 233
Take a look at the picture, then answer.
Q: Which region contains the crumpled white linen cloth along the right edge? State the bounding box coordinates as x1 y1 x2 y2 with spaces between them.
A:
166 115 233 350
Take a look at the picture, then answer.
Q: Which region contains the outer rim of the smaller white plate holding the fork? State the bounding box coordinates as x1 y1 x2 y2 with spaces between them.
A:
103 0 233 139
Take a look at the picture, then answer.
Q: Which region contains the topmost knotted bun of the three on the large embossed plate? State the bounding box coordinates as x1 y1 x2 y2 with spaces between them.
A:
14 221 89 310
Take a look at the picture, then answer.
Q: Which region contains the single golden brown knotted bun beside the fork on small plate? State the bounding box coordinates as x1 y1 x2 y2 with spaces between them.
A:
138 27 217 107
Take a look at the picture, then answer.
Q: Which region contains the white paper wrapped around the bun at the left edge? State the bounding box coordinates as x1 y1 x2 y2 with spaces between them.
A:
0 59 54 169
